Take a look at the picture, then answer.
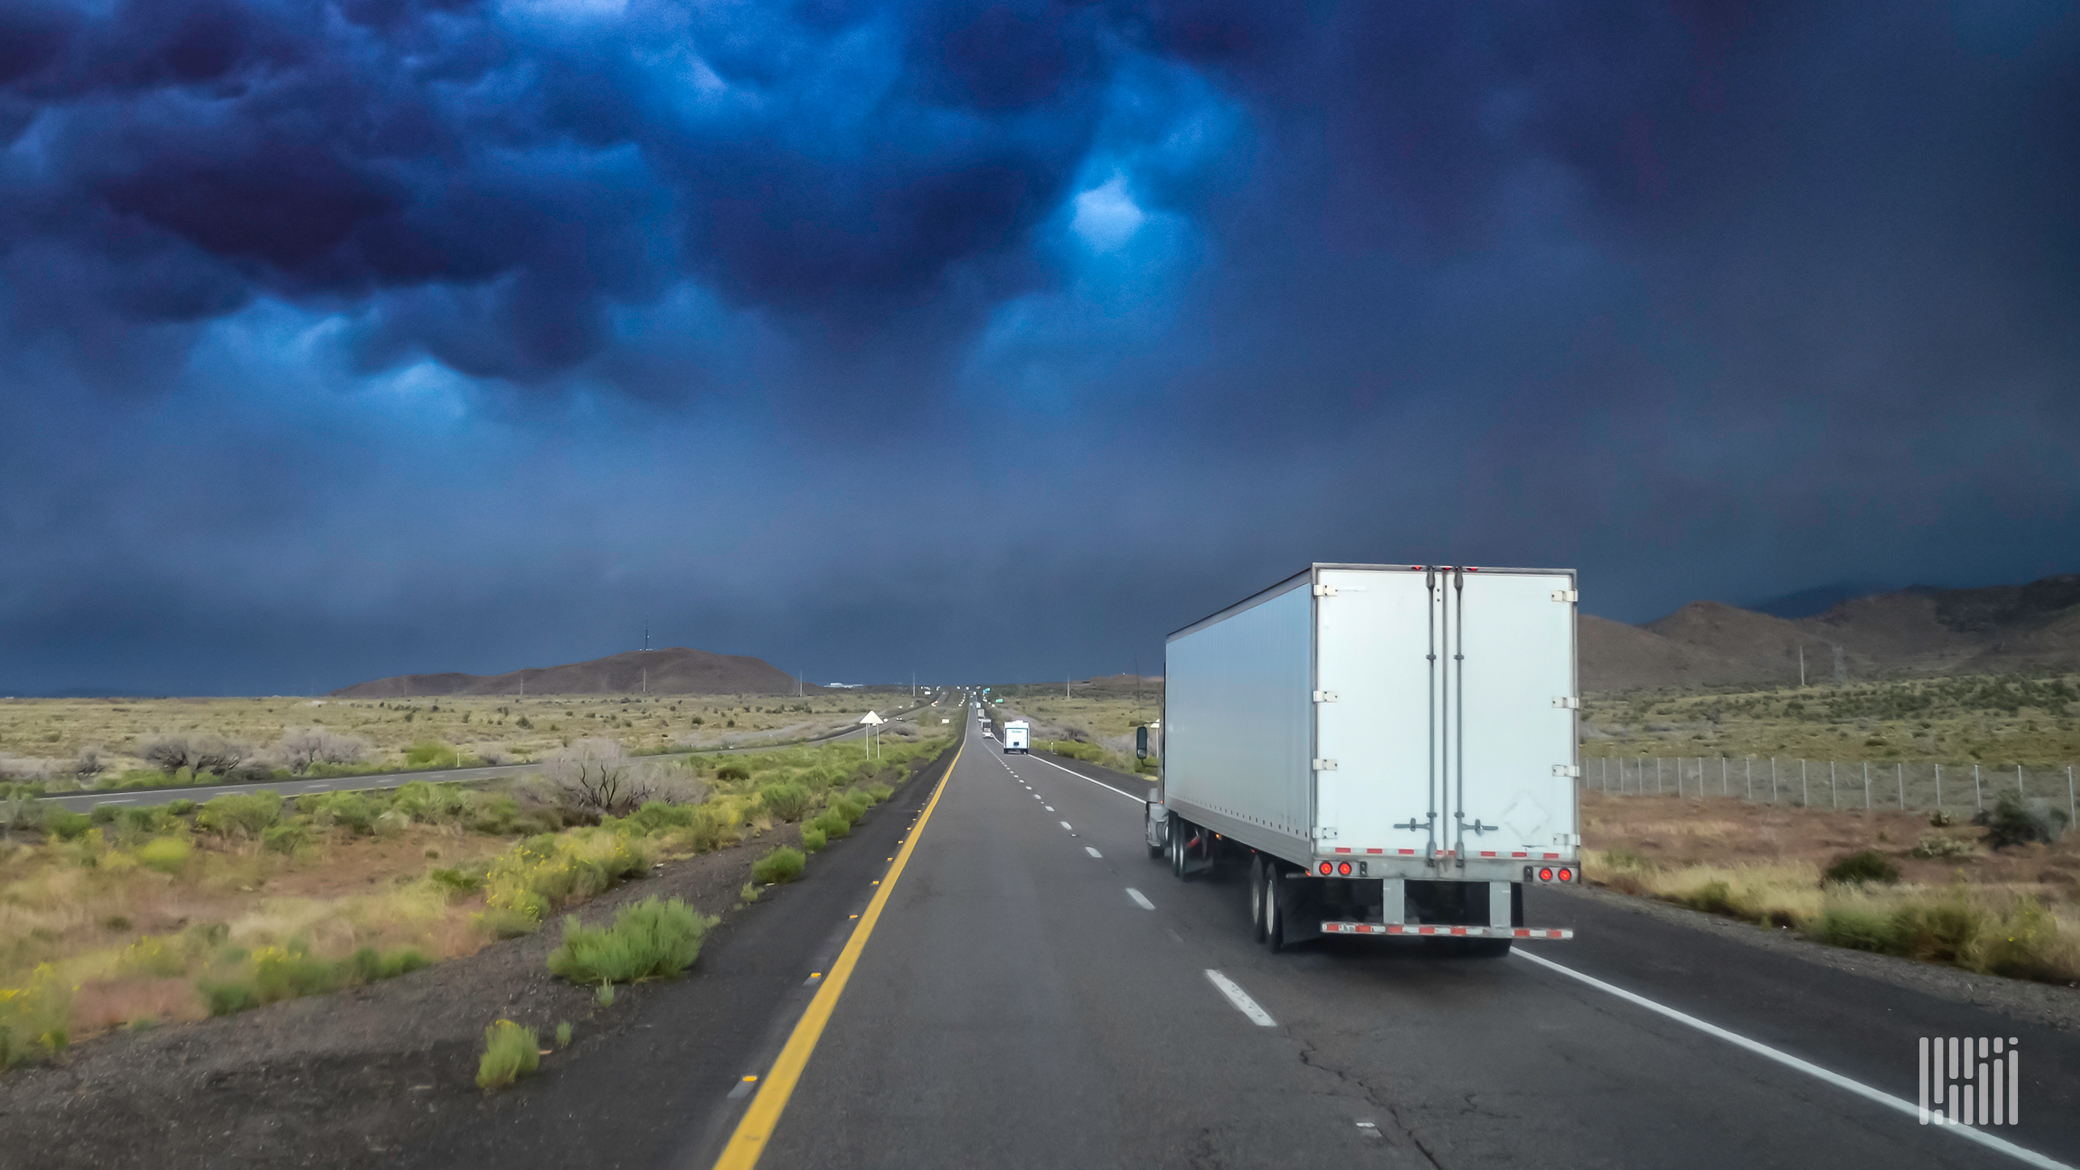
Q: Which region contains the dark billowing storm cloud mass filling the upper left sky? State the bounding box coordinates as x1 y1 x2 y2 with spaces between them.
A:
0 0 1139 377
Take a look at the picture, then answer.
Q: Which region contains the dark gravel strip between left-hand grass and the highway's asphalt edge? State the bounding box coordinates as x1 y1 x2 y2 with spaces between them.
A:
0 824 799 1168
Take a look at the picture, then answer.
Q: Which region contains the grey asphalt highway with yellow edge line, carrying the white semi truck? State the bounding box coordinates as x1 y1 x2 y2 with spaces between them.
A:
698 699 2080 1170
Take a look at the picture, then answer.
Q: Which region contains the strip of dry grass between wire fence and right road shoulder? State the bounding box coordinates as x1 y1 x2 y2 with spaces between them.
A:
1581 793 2080 983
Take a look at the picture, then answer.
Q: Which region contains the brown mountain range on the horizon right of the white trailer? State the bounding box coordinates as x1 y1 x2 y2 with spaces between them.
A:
1579 573 2080 691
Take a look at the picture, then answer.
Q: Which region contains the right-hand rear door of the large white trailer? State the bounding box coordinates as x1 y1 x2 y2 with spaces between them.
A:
1439 568 1581 858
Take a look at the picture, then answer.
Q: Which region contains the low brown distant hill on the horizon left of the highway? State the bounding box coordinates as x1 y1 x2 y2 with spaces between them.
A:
333 645 820 700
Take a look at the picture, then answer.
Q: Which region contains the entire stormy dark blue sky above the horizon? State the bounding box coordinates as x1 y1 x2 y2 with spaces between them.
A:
0 0 2080 693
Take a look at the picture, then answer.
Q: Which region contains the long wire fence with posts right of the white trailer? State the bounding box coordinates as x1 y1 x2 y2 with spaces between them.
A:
1581 756 2080 824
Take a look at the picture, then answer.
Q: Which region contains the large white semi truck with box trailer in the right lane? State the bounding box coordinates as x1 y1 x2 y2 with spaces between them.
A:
1144 564 1581 956
